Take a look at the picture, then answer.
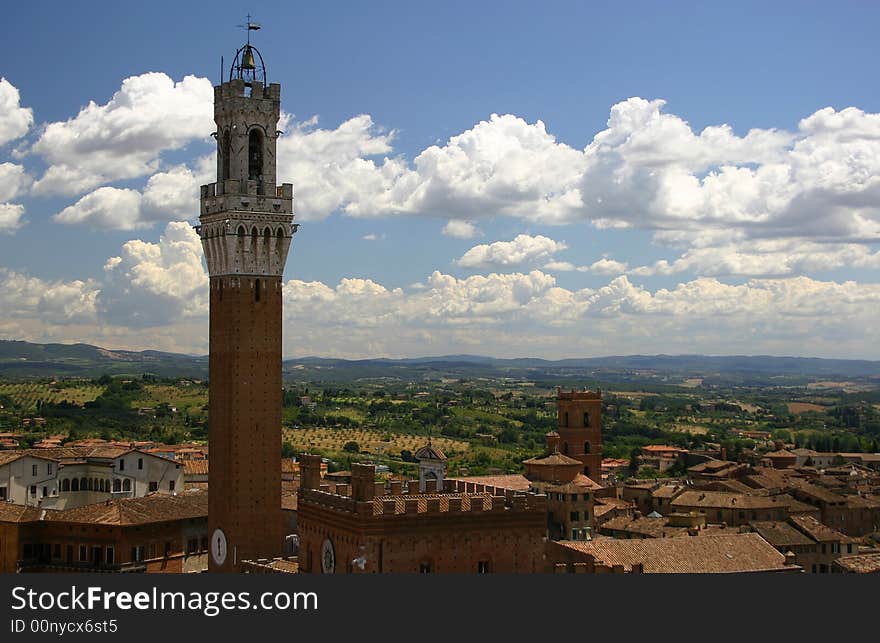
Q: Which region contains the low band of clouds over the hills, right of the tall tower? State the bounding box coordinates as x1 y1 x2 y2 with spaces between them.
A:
284 271 880 357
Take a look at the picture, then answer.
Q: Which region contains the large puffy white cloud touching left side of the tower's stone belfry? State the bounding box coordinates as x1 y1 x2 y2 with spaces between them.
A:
31 72 214 195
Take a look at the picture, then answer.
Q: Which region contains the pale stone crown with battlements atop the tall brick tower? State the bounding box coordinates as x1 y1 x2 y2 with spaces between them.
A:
196 70 298 277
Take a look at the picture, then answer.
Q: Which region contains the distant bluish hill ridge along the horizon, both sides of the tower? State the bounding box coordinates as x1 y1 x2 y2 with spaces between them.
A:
0 340 880 380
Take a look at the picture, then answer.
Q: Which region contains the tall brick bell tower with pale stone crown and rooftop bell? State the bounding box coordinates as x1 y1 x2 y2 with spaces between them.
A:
196 22 297 572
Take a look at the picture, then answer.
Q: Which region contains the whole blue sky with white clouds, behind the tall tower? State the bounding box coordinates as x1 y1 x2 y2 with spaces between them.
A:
0 2 880 358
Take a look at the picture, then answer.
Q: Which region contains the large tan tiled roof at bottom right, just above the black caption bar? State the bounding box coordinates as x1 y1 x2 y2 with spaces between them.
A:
559 533 799 574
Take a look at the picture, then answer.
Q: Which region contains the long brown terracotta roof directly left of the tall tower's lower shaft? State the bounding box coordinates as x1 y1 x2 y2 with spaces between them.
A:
46 491 208 526
